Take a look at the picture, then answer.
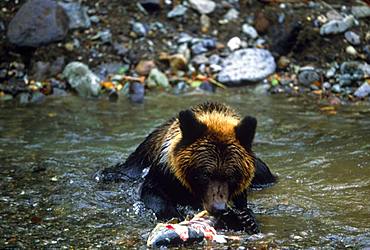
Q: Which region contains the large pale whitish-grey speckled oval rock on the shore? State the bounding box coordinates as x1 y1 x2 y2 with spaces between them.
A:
218 48 276 85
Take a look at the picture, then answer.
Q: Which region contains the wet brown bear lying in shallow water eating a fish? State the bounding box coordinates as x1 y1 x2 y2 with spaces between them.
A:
101 102 276 232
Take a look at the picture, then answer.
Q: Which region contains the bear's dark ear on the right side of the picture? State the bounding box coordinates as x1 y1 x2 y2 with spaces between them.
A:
235 116 257 149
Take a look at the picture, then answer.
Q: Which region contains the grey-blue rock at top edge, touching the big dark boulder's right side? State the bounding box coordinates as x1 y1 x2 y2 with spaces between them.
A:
59 2 91 29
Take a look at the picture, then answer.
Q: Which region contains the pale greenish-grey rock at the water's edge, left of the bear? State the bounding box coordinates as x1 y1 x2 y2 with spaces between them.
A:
63 62 101 97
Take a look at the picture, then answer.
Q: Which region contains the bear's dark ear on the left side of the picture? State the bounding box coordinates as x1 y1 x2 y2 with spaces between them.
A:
179 110 207 143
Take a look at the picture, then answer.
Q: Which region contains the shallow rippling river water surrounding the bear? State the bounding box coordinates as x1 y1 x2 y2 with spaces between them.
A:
0 93 370 249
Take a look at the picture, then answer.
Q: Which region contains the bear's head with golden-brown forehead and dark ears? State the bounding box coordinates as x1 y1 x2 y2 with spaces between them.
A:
170 110 257 213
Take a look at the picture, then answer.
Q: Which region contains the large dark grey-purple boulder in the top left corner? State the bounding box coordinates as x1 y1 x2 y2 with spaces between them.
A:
7 0 69 48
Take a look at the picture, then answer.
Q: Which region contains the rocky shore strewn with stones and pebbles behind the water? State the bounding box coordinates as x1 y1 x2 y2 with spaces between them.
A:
0 0 370 104
